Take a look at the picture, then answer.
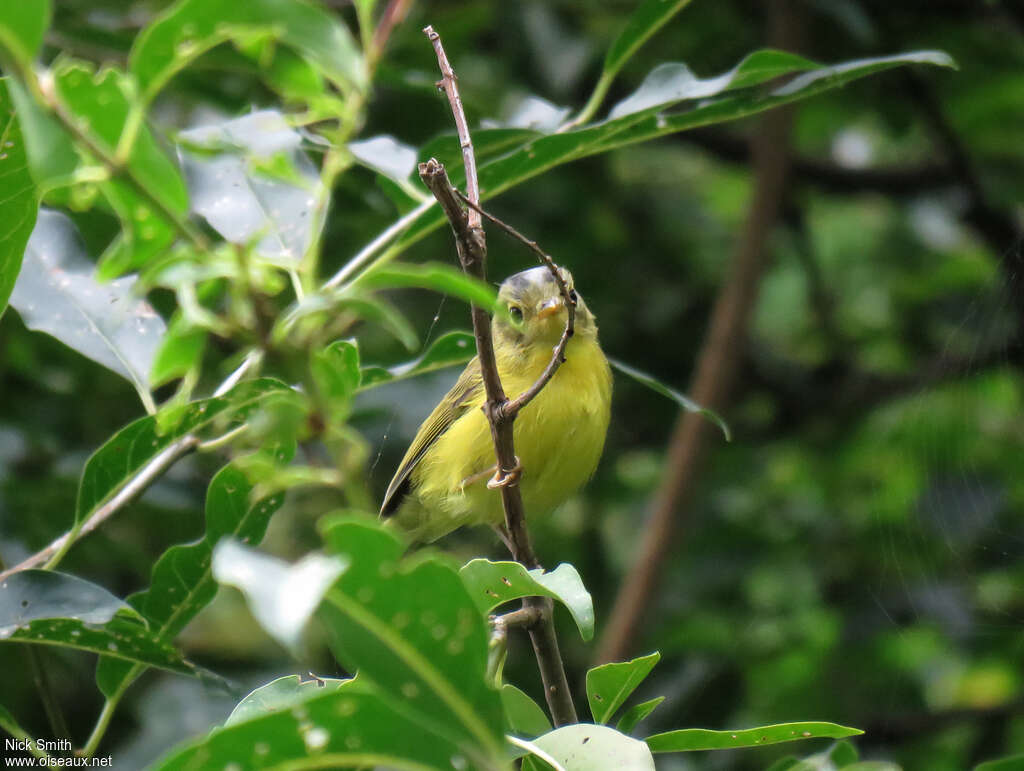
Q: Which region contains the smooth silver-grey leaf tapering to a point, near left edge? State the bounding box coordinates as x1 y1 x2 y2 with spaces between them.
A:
10 209 167 403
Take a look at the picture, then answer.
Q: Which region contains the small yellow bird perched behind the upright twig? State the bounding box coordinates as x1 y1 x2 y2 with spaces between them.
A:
381 266 611 541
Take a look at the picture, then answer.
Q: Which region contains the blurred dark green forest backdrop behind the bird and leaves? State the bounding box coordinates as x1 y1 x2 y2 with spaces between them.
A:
0 0 1024 771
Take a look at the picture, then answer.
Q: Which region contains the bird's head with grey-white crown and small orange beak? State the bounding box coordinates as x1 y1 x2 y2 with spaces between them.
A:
495 265 597 346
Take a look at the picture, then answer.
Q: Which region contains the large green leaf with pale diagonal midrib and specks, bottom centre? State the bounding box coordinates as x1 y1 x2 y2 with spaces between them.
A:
319 517 503 766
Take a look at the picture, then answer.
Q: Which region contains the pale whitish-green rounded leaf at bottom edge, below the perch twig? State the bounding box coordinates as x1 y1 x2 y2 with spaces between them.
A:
522 723 654 771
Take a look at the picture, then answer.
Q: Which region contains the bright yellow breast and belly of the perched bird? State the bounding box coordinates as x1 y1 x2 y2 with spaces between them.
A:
398 338 611 541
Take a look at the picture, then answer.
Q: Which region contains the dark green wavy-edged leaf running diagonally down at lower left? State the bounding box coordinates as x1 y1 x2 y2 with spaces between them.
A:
96 447 294 697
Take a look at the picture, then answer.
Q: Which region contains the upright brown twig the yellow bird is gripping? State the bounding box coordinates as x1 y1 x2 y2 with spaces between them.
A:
419 27 577 726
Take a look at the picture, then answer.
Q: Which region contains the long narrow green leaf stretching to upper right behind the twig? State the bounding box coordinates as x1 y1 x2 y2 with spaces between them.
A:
372 51 952 270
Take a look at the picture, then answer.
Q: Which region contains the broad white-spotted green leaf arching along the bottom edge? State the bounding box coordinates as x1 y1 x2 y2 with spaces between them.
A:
154 678 477 771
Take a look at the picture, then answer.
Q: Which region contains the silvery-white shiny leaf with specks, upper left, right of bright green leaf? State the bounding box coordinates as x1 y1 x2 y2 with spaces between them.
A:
178 110 324 265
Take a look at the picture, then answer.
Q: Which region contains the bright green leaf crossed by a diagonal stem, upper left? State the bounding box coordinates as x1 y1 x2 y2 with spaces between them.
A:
53 59 188 280
